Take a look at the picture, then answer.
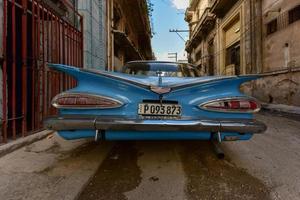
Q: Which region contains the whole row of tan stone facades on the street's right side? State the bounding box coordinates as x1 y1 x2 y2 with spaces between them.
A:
185 0 300 106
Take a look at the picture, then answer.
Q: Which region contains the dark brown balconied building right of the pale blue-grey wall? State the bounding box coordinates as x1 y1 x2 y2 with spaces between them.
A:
107 0 153 71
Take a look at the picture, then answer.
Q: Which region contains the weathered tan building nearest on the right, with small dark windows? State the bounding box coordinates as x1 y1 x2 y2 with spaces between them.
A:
252 0 300 106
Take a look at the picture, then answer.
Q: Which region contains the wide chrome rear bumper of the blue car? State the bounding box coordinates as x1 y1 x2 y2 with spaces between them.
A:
44 116 267 133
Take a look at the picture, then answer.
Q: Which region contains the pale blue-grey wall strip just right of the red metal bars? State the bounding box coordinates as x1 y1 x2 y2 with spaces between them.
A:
78 0 107 69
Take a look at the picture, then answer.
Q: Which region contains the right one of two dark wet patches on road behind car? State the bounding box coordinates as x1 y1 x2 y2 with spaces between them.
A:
181 141 270 200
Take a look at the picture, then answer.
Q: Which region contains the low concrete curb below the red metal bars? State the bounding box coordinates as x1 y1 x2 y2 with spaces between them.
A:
0 130 54 158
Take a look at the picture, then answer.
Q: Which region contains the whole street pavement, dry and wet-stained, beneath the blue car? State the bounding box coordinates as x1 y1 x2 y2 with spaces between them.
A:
0 112 300 200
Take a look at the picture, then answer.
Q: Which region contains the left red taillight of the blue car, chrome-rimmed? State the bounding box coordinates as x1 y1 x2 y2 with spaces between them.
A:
52 93 123 109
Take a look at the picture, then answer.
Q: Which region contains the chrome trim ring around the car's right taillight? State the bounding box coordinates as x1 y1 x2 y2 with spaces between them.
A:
198 96 261 113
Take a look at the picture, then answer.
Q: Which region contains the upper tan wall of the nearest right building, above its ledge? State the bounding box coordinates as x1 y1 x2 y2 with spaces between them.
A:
262 0 300 72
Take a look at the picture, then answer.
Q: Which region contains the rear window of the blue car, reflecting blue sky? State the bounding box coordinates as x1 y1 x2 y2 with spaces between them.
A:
122 62 200 77
